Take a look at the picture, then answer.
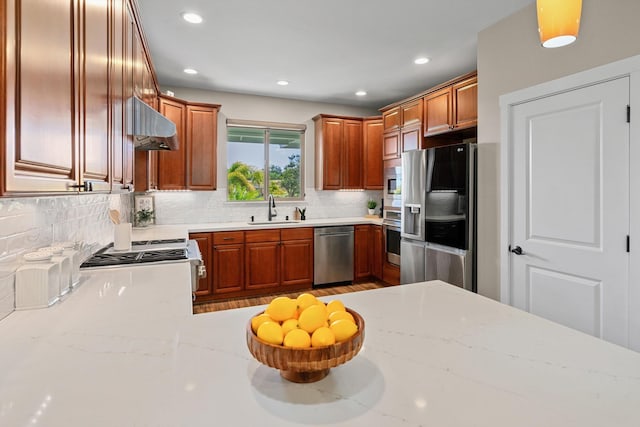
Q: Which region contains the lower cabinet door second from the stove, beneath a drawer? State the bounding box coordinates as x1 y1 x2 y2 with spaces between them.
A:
211 244 244 295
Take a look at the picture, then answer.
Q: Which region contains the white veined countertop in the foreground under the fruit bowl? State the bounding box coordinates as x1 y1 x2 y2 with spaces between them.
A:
0 263 640 427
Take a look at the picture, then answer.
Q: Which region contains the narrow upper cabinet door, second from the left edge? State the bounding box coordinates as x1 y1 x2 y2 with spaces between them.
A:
80 0 111 190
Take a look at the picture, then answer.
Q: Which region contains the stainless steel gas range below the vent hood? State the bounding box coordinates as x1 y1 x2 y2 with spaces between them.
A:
80 239 207 292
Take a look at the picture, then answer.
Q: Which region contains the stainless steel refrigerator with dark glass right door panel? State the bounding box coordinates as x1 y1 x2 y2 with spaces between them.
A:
400 144 476 292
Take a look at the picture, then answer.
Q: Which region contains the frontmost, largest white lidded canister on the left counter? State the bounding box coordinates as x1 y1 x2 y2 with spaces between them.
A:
16 251 60 310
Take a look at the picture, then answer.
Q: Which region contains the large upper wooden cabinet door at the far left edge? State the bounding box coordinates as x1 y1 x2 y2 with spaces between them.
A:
0 0 79 192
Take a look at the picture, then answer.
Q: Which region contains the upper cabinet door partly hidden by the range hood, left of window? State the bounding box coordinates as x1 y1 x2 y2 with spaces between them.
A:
158 97 188 190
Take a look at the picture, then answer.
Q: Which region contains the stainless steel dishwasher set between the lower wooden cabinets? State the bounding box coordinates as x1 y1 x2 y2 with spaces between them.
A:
313 225 353 286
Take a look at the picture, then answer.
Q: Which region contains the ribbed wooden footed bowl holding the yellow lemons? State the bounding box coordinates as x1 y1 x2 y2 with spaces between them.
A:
247 308 364 383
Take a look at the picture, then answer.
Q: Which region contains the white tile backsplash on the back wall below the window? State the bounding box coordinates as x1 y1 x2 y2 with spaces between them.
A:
149 188 382 224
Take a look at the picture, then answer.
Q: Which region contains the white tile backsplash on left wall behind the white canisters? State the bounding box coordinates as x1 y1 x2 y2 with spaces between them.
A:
0 194 133 319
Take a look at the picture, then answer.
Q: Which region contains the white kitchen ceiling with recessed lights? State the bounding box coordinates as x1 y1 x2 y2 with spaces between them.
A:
138 0 533 109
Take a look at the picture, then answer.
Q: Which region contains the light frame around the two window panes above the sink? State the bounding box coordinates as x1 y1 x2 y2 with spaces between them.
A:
225 119 307 203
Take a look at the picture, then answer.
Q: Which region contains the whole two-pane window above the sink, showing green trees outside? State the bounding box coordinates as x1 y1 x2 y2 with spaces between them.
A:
227 120 306 201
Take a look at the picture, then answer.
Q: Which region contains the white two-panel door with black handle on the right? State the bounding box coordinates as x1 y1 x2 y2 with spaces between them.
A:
508 77 629 346
